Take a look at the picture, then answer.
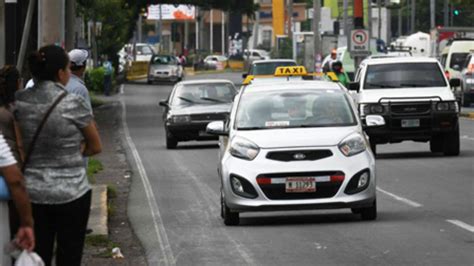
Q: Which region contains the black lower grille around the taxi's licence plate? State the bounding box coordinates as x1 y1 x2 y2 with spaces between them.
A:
259 171 343 200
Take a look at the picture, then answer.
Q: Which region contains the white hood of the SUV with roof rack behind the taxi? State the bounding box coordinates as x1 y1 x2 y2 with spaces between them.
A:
359 87 454 103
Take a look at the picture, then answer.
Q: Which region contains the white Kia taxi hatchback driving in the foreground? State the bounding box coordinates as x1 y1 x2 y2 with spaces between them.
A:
207 67 384 225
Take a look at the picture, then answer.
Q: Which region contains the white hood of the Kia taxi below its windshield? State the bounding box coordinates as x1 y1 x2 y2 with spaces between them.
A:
237 126 357 149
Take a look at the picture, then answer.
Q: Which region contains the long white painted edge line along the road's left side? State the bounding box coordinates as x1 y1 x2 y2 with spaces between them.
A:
120 86 176 266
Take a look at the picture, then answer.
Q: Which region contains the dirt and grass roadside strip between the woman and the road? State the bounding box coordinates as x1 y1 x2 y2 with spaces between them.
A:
82 91 147 266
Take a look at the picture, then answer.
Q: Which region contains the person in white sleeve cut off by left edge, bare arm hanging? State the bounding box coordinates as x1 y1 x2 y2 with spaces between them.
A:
0 134 35 266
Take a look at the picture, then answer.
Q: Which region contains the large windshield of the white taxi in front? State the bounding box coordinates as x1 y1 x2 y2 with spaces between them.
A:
236 90 356 130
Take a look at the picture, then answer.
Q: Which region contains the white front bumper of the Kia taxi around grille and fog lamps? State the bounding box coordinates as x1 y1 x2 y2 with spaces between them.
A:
220 147 376 212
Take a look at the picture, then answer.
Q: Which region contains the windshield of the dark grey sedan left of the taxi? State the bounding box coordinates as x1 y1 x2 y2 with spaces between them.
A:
171 83 237 106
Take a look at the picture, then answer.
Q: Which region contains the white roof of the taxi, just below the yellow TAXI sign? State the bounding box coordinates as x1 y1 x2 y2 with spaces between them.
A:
244 79 344 93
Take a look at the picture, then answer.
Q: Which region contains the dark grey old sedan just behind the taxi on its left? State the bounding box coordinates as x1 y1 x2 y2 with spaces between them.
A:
160 79 237 149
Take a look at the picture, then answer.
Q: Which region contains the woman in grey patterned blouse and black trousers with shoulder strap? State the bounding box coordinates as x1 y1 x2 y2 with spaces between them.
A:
15 45 102 266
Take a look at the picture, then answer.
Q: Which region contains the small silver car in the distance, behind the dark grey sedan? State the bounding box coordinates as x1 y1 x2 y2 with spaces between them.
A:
148 55 184 84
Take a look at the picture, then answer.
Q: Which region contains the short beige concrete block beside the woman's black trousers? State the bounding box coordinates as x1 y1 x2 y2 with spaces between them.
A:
87 185 109 236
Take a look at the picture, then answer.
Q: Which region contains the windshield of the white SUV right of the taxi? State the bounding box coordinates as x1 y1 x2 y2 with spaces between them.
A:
364 63 446 90
